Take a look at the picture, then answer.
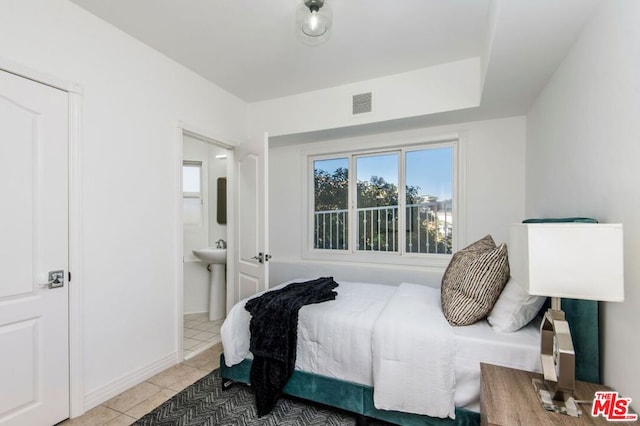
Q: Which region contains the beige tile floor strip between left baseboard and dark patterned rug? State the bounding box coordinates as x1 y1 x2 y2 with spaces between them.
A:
59 343 222 426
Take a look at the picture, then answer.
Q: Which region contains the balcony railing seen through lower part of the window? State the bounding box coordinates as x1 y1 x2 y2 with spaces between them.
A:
314 200 453 254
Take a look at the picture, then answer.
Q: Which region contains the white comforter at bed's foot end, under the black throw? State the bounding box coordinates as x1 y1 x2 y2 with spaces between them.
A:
220 279 396 386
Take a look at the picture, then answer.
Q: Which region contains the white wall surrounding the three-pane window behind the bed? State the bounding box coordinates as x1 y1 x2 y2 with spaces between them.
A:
269 117 526 285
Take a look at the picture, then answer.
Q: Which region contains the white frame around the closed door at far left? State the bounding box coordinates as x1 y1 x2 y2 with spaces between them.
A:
0 57 85 418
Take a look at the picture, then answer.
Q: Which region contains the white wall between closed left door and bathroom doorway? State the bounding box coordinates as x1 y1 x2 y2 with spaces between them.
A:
0 0 246 408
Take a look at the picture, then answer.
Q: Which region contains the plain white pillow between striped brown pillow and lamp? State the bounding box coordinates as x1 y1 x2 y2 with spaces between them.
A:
487 278 547 333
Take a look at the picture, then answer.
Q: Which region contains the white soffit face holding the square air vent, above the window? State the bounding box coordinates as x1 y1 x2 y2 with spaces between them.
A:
249 58 482 138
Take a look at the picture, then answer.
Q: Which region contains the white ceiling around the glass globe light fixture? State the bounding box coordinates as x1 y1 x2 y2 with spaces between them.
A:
71 0 601 114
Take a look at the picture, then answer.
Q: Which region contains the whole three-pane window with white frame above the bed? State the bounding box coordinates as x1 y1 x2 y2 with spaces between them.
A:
310 142 456 256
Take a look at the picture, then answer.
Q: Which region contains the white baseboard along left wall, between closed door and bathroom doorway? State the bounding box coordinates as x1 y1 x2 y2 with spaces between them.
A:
79 352 178 415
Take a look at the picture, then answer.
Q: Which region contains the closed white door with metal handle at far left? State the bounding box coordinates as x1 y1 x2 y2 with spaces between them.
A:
0 71 69 426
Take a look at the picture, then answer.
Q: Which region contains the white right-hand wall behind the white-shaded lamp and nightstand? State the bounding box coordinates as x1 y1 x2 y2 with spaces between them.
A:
526 0 640 409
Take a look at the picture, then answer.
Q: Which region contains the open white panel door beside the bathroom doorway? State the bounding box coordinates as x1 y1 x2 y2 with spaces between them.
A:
233 134 270 303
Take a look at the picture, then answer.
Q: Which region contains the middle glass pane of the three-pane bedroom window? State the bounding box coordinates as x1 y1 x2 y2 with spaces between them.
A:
356 154 398 252
